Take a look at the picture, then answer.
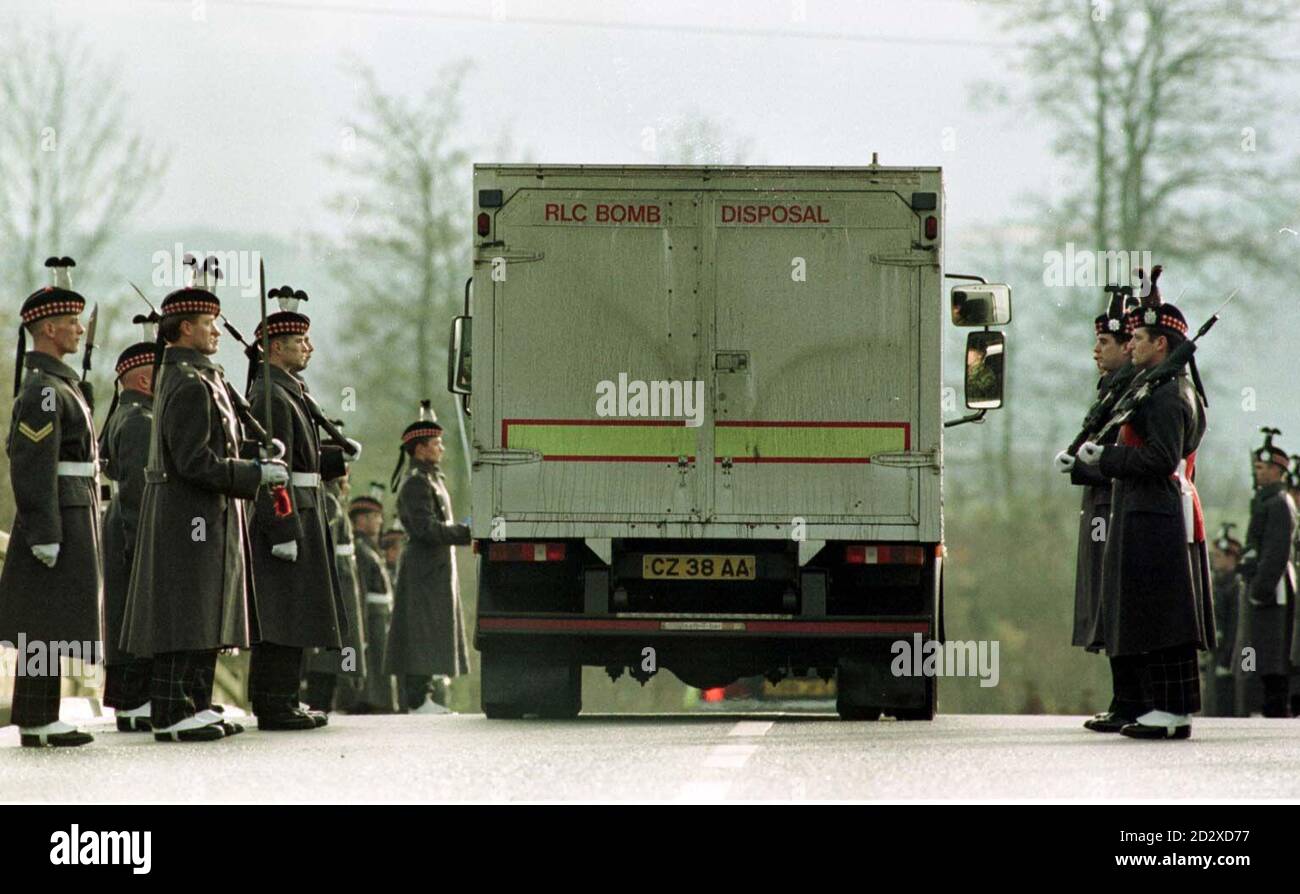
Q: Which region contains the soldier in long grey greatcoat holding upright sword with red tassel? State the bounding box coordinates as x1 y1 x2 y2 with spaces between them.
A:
122 262 289 742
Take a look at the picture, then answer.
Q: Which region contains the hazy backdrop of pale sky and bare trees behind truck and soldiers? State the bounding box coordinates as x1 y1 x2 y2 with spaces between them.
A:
0 0 1300 712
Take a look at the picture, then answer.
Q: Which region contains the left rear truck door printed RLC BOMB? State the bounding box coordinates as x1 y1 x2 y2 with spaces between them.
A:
480 188 710 522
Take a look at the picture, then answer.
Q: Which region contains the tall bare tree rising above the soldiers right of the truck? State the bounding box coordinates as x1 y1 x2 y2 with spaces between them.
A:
982 0 1295 278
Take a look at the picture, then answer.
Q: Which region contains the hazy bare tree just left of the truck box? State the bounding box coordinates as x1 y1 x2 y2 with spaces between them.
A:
328 64 471 436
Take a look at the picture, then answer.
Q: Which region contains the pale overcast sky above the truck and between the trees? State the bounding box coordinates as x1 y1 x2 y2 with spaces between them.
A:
0 0 1053 235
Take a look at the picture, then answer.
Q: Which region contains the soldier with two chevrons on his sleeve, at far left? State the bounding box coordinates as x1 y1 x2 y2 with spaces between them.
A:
0 257 103 747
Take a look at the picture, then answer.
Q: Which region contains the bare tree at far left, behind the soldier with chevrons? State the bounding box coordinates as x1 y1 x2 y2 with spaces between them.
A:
0 30 166 295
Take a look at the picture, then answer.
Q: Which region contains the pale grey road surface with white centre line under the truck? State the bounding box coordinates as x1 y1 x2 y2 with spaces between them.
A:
0 713 1300 803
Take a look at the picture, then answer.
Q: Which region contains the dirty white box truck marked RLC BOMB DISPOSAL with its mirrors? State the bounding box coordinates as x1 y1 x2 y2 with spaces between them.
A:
449 164 1010 719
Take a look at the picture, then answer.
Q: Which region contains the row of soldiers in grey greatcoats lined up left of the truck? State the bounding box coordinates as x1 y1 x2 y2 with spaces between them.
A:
0 249 483 747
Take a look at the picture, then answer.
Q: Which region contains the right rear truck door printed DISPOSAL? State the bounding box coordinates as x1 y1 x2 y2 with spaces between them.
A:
705 191 920 525
